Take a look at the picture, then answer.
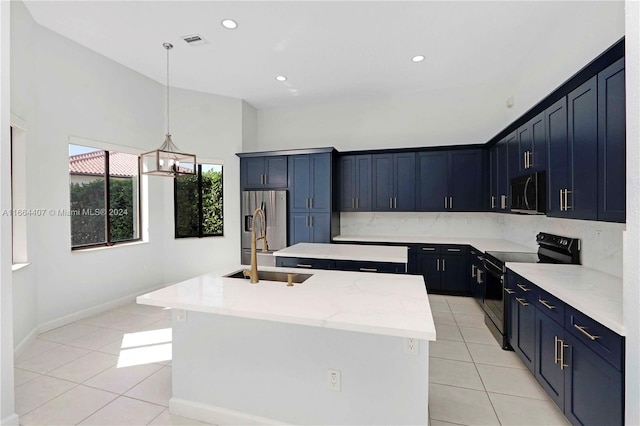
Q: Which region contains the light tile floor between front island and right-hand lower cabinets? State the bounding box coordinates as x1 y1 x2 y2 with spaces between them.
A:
429 295 569 426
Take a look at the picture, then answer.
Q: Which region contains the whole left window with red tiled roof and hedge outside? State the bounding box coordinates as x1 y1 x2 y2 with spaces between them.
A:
66 145 140 249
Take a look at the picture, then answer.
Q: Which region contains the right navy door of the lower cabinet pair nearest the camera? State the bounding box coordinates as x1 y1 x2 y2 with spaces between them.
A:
563 333 624 426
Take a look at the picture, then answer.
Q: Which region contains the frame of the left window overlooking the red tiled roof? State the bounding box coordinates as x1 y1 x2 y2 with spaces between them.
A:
69 146 142 251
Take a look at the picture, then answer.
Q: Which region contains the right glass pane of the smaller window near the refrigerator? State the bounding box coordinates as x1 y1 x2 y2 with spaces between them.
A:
202 164 223 235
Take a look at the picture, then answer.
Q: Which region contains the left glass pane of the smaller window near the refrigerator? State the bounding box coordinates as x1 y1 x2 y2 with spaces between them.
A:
174 171 200 237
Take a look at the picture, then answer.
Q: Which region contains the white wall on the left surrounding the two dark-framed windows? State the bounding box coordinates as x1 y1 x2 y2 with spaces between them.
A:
10 2 243 347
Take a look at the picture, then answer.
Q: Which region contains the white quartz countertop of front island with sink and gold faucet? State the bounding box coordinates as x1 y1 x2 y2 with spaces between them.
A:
137 265 436 340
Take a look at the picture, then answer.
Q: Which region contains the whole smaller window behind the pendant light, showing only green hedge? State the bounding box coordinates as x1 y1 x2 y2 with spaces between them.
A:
173 164 223 238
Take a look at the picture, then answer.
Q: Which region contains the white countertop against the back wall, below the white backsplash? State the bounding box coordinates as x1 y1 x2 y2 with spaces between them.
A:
333 235 538 253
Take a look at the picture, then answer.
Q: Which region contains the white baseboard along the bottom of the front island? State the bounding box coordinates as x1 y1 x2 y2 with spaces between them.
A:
169 398 286 426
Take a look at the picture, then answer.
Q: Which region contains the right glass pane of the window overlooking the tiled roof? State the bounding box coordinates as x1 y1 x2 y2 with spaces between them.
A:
108 151 139 242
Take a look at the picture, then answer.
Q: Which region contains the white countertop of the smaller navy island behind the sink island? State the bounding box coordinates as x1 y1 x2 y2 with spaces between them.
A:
273 243 408 263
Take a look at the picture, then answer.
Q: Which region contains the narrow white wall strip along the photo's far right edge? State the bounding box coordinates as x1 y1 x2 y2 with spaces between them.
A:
623 1 640 425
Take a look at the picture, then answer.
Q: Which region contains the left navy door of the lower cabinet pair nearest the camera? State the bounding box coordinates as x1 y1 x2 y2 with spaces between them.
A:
534 310 567 410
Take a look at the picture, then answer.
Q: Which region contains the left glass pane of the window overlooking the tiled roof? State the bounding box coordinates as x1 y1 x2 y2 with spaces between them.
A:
69 145 106 247
